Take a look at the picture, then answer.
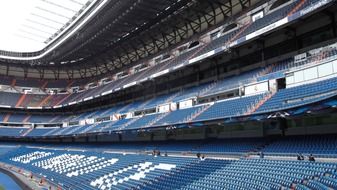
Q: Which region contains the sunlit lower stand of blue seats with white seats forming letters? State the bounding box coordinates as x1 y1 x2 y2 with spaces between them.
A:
0 145 337 190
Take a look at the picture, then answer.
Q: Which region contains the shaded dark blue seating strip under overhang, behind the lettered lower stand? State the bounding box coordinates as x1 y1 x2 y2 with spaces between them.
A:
1 136 337 157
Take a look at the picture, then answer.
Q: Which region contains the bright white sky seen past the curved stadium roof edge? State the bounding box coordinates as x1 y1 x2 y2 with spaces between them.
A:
0 0 87 52
